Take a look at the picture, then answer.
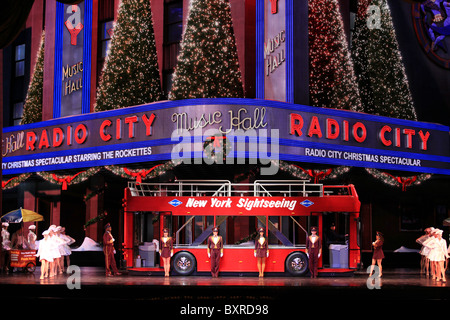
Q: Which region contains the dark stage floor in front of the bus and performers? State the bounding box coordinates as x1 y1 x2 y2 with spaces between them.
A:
0 267 450 319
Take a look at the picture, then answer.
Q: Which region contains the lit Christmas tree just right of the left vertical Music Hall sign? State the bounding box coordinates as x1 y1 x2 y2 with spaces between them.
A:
95 0 162 111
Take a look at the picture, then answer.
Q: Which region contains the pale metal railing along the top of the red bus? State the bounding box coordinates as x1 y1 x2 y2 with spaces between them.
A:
128 180 351 197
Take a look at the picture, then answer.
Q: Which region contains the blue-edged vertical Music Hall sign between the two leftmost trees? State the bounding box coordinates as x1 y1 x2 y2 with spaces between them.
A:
53 0 92 118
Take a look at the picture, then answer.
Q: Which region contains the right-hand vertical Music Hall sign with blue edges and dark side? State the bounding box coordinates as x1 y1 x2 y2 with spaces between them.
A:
256 0 309 104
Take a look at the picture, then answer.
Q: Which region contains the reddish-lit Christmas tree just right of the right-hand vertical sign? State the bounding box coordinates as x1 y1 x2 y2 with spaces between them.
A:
308 0 362 111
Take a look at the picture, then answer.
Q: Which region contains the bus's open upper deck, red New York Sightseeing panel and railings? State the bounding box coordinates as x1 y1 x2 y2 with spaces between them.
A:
124 180 360 216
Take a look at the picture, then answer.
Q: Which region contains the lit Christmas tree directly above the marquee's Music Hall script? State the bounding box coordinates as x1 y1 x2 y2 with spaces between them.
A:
169 0 243 100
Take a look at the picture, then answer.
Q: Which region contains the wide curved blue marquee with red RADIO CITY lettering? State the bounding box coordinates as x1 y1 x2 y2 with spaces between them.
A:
2 98 450 175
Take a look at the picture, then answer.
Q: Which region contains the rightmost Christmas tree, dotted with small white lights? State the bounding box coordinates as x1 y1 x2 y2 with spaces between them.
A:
352 0 417 120
